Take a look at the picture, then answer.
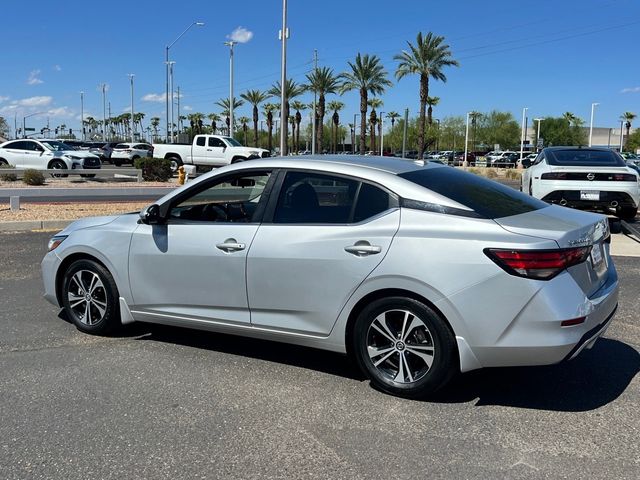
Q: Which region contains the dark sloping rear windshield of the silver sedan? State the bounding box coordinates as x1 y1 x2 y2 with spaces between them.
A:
399 167 549 219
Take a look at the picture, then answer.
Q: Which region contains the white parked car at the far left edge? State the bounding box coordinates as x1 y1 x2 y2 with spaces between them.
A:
0 139 101 177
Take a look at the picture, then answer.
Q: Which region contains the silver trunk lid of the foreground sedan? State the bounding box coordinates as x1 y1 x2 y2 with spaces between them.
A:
494 205 611 297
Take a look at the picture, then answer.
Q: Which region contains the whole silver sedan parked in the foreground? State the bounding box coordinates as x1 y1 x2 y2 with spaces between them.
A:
42 156 618 397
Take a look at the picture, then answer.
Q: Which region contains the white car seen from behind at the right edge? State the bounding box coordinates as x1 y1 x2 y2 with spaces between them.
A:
522 147 640 220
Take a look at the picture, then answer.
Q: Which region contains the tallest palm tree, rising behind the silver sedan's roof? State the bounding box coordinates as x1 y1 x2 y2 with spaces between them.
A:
393 32 459 158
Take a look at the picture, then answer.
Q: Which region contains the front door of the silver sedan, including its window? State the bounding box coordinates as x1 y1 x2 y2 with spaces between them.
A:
129 170 271 326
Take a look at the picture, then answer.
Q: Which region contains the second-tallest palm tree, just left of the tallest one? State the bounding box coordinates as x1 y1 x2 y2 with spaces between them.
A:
339 53 391 153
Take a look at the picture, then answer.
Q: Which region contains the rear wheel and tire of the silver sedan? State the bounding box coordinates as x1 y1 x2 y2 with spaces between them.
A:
351 297 459 398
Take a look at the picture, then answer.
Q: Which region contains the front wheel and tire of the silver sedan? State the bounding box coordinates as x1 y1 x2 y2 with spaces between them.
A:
62 260 121 335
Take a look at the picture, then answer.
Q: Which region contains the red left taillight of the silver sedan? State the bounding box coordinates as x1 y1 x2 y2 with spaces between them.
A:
484 246 591 280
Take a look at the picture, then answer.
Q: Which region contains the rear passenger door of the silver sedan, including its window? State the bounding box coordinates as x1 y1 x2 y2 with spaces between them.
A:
247 171 400 336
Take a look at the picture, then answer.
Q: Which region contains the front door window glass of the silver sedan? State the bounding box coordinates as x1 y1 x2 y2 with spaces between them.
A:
169 172 271 223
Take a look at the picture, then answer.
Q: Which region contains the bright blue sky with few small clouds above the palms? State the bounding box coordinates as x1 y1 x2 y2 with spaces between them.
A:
0 0 640 135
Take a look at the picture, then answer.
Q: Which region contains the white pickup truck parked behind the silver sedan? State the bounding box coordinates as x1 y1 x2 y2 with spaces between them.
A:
153 135 270 171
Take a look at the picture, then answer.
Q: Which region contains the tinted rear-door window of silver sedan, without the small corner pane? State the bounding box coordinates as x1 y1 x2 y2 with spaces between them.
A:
273 172 360 224
